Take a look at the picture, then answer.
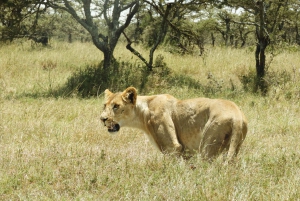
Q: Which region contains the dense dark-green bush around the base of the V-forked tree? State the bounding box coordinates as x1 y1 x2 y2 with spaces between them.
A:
55 61 142 98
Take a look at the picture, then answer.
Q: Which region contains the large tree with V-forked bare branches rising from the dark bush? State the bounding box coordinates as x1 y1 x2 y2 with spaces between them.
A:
47 0 140 69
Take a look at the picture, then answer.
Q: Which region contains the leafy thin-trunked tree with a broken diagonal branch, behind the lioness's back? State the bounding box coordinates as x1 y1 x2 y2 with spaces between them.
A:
124 0 210 68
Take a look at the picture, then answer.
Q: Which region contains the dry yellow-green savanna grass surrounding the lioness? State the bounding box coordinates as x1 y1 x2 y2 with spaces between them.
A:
0 41 300 200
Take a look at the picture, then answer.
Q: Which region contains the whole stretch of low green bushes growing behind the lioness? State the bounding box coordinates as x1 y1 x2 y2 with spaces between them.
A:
53 55 206 98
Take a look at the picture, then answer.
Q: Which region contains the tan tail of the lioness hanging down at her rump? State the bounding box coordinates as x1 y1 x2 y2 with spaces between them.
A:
227 114 248 162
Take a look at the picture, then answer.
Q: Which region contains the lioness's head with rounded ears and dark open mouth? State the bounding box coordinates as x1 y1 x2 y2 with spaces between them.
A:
100 87 137 132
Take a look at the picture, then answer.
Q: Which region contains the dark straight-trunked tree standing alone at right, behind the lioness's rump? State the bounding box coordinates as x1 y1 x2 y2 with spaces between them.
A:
219 0 290 94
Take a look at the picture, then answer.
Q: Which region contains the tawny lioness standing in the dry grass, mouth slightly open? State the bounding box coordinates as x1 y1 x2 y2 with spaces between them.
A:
100 87 247 161
